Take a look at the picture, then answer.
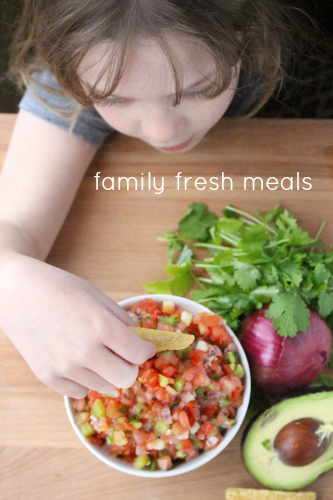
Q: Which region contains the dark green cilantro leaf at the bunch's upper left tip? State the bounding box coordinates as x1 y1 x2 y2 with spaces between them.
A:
179 203 217 241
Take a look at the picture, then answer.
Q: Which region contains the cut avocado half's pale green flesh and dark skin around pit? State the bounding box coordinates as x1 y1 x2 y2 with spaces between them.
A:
242 387 333 490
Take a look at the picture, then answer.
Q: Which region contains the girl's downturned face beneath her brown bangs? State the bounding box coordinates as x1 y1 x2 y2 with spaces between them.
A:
80 38 240 153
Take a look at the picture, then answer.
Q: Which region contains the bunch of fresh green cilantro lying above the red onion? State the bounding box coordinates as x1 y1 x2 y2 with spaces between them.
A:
144 203 333 337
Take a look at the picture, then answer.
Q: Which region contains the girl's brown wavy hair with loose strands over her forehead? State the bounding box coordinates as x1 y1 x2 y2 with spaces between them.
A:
10 0 293 115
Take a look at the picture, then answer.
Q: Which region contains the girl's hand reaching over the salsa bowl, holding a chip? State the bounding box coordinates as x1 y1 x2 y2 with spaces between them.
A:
0 253 155 399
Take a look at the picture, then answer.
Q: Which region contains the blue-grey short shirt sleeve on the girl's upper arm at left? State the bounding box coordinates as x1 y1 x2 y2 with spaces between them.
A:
19 71 114 148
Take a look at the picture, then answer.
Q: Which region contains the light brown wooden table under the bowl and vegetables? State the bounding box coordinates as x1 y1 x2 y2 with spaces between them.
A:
0 115 333 500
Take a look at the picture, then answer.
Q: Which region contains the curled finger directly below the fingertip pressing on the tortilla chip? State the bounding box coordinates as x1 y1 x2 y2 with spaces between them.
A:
88 346 139 389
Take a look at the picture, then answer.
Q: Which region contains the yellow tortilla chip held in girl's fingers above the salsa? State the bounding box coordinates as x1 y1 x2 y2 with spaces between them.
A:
130 326 195 352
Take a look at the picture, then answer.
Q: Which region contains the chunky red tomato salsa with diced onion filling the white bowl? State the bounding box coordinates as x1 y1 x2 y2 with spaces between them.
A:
73 298 244 471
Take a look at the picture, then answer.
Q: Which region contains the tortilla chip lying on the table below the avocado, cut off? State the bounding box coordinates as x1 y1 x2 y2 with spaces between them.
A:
225 488 317 500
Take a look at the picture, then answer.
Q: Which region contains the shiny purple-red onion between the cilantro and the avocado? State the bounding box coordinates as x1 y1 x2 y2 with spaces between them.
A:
241 306 332 394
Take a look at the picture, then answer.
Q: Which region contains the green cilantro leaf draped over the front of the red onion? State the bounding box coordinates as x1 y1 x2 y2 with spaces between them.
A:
265 292 310 337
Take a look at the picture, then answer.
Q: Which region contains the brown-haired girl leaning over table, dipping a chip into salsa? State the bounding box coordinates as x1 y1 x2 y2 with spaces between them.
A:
0 0 290 398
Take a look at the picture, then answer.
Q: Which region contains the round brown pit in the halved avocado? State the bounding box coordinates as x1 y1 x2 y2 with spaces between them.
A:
274 418 331 467
